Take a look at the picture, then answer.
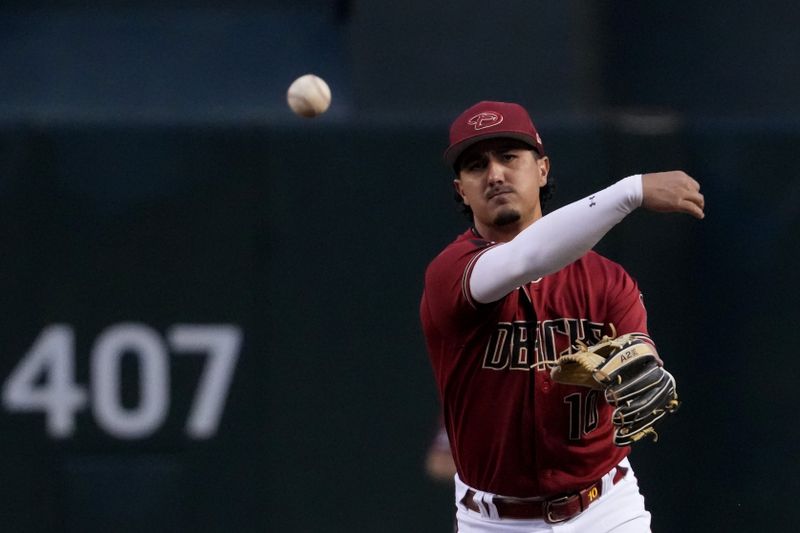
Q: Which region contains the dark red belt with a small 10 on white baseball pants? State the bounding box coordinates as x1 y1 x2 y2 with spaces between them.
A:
461 466 628 524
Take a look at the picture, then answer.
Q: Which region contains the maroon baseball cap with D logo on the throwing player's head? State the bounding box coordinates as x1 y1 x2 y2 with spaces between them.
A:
444 100 544 166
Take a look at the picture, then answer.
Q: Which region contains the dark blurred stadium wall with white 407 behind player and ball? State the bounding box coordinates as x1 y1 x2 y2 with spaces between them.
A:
0 0 800 533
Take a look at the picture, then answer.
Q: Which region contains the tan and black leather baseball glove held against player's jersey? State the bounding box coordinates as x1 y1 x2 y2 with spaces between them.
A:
551 333 680 446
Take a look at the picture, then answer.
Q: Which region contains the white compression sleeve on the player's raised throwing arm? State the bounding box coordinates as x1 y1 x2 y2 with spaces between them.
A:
469 174 642 303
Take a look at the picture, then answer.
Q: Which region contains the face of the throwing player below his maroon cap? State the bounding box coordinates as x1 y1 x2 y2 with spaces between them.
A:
453 139 550 240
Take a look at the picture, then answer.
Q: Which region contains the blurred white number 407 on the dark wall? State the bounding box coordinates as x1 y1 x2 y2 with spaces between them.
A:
3 323 242 439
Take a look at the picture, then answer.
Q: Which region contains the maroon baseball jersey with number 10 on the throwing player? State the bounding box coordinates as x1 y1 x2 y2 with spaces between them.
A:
420 230 647 497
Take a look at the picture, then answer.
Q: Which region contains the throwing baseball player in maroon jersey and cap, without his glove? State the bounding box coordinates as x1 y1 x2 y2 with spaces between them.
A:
420 101 704 533
